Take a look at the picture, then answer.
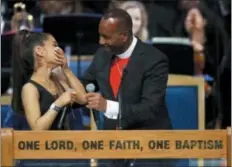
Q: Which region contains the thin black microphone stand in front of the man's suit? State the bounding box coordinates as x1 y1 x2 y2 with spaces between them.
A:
117 66 127 130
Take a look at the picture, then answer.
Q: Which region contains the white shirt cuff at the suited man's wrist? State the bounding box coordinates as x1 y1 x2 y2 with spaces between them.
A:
104 100 119 119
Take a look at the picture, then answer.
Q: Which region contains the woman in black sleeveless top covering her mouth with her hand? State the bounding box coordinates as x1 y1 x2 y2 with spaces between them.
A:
12 30 86 130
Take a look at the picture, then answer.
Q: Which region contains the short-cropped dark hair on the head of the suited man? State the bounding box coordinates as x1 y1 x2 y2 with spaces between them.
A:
102 8 133 36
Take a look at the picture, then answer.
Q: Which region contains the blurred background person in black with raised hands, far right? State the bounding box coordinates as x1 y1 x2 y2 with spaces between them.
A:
185 3 231 128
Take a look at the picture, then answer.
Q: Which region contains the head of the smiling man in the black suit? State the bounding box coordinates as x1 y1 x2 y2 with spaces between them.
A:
99 9 133 54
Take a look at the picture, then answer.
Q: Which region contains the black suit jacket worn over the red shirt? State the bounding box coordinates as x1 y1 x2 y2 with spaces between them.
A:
83 40 172 130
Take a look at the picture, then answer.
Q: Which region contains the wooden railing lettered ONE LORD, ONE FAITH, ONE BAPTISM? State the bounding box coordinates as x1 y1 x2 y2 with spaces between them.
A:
1 128 231 166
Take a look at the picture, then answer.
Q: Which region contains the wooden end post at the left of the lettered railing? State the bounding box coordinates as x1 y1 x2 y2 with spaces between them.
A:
1 129 14 166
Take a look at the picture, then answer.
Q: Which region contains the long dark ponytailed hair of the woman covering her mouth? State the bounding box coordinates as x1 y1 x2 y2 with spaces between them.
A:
12 30 48 114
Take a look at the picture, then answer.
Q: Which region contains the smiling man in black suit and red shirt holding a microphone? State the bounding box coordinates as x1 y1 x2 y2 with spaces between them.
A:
83 9 172 167
